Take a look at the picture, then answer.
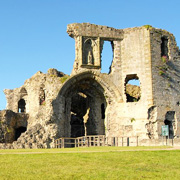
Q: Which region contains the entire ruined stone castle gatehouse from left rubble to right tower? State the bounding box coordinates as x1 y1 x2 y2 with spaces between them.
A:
0 23 180 148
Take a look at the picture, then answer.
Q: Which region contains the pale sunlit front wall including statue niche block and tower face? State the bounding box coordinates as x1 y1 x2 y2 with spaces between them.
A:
67 23 156 137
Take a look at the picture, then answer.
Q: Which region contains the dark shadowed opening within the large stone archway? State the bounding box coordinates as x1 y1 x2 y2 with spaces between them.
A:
65 77 106 137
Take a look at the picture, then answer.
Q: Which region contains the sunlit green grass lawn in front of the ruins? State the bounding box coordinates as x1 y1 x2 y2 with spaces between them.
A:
0 147 180 180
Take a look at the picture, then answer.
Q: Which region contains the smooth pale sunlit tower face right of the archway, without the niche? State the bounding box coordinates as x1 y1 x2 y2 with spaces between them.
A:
110 27 153 138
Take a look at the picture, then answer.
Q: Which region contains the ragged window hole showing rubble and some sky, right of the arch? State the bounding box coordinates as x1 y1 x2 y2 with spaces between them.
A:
125 74 141 102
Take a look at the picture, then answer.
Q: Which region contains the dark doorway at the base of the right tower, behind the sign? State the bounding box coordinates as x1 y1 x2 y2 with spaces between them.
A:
164 111 175 139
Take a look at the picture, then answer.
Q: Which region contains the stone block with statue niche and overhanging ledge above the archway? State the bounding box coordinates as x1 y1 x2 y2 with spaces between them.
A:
67 23 123 74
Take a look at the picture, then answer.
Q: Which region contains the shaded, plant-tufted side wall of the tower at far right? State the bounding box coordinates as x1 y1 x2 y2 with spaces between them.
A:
150 28 180 136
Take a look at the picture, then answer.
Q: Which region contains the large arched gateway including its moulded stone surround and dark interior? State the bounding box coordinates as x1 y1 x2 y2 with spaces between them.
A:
54 71 121 137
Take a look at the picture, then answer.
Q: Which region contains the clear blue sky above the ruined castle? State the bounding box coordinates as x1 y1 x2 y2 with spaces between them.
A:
0 0 180 110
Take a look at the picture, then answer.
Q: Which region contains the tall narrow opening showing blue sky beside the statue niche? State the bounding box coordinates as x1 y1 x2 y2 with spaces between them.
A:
101 41 114 73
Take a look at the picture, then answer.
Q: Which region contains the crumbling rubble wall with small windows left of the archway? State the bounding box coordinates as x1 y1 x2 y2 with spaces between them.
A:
0 69 69 148
